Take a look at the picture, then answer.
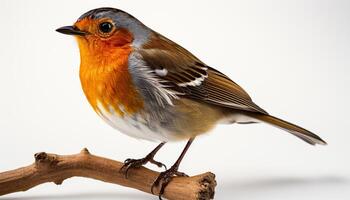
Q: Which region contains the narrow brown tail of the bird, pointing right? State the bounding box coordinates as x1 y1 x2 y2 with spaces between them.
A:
246 113 327 145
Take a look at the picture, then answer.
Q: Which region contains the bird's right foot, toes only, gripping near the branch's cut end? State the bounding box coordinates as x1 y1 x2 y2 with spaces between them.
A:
151 167 188 200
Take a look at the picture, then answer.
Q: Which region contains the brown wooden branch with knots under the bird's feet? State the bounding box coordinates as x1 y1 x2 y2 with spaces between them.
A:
0 149 216 200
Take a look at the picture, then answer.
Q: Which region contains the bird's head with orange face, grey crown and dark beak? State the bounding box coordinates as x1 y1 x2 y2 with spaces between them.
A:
56 8 151 59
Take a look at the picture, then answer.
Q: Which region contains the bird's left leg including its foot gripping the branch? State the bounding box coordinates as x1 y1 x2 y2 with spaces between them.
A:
120 142 167 178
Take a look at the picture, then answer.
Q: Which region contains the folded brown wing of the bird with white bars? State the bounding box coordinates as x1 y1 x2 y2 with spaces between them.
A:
138 34 267 114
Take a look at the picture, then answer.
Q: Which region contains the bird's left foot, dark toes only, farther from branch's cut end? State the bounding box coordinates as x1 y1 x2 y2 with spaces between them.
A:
120 156 167 178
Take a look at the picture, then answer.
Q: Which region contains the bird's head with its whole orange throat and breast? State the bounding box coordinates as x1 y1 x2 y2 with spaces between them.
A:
57 8 148 115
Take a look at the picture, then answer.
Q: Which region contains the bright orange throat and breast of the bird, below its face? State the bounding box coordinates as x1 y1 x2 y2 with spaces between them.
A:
78 30 143 115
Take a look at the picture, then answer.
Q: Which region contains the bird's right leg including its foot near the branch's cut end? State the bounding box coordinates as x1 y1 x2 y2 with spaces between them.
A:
151 138 194 200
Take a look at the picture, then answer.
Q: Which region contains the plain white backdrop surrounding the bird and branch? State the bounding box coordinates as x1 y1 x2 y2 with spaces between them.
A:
0 0 350 200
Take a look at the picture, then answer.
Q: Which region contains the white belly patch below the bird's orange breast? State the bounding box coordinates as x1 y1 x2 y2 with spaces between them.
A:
97 102 172 142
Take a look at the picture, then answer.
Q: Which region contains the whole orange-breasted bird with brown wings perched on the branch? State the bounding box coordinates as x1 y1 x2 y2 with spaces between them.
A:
56 7 326 199
